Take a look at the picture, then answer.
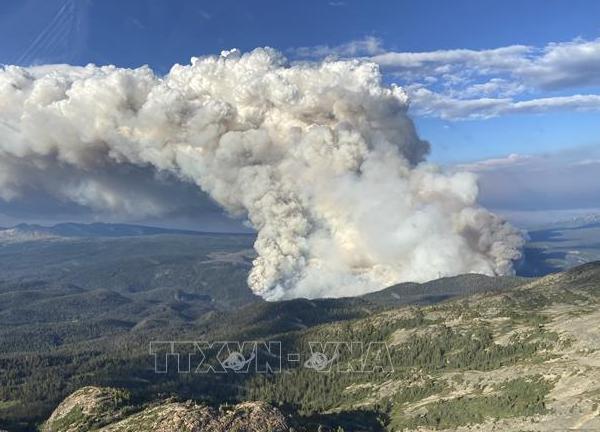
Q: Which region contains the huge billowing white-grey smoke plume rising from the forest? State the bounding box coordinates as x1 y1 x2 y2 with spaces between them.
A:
0 49 523 299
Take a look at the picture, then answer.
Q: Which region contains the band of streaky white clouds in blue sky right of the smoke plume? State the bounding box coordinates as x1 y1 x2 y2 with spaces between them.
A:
295 38 600 120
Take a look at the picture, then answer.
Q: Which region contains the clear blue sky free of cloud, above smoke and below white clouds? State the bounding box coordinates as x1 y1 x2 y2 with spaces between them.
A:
0 0 600 163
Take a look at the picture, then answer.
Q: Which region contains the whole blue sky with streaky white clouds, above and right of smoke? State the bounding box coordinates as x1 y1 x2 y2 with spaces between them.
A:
0 0 600 228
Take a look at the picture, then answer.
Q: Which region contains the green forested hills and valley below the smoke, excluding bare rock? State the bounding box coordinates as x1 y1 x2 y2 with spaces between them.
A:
0 230 600 431
